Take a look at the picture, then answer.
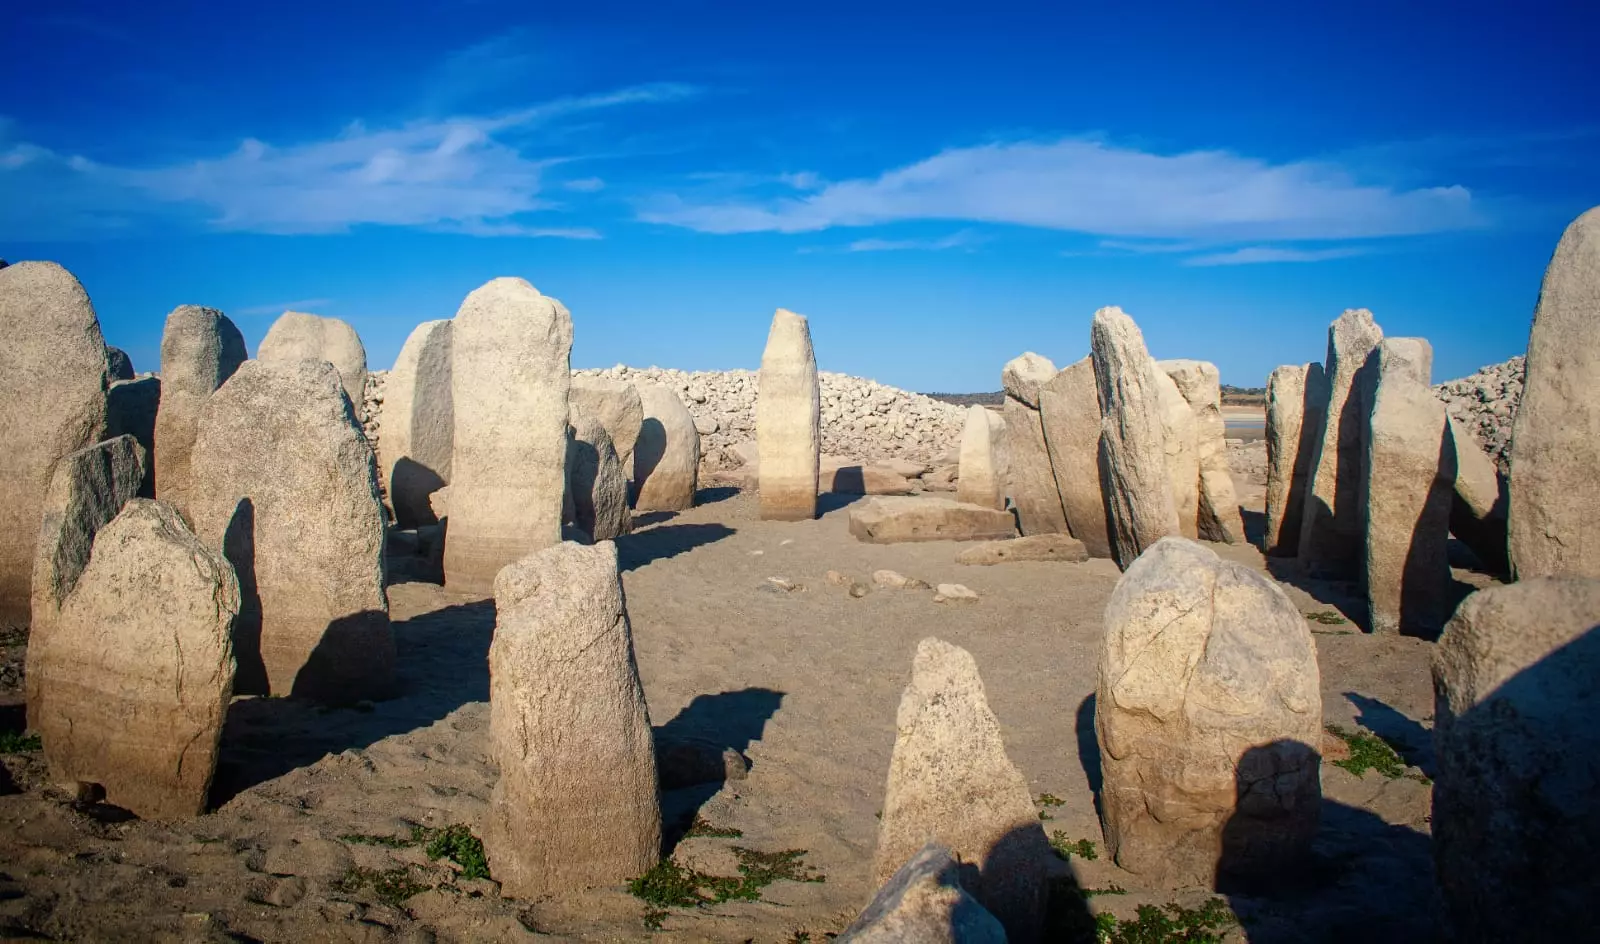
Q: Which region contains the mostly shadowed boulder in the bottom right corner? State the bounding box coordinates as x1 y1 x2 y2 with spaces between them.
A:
1432 582 1600 944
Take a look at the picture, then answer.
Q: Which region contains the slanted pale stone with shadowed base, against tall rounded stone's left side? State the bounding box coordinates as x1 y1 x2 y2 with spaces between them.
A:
378 318 456 528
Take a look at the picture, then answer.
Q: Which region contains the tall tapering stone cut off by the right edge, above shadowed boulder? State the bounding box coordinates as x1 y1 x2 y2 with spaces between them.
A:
1510 206 1600 579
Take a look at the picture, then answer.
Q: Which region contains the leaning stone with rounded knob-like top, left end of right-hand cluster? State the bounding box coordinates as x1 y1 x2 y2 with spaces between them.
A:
1000 350 1067 534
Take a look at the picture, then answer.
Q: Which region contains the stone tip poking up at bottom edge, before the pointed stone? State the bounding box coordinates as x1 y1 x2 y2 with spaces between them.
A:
834 842 1006 944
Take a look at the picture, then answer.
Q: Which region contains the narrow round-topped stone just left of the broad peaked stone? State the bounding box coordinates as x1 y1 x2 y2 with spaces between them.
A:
152 306 246 514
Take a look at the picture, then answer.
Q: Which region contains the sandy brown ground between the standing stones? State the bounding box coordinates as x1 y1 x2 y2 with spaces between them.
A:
0 457 1484 942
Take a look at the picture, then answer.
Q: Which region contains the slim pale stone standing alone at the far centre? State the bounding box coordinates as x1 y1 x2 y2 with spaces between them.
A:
755 309 822 522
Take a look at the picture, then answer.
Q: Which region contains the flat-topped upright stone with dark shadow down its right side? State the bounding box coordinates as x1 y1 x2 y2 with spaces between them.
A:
1362 338 1456 635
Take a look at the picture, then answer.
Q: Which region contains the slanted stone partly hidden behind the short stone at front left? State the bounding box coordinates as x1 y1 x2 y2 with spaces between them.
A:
24 435 144 730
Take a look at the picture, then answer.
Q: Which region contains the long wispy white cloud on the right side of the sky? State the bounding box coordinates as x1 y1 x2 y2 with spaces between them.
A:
640 138 1485 242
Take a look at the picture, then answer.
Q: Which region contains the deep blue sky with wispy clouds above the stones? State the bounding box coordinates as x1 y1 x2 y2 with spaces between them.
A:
0 0 1600 390
